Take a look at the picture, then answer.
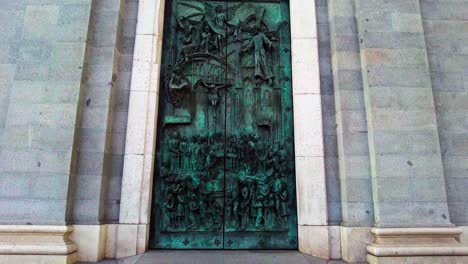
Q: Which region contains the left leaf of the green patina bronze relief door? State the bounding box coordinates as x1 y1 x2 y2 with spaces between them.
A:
150 0 227 249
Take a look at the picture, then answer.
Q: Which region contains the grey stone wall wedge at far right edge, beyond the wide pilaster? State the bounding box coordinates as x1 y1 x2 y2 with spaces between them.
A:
420 0 468 225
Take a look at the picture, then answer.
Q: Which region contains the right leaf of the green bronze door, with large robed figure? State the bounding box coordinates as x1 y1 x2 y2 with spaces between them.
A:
224 0 297 249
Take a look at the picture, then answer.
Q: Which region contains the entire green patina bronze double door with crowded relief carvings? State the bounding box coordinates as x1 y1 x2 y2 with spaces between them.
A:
150 0 297 249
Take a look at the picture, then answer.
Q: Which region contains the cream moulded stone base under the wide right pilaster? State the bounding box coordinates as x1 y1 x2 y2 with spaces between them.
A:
367 228 468 264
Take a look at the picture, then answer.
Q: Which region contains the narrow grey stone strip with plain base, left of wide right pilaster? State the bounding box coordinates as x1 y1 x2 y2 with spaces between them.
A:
328 0 374 262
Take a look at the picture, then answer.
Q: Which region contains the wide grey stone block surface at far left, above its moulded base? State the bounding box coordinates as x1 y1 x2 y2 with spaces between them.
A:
0 0 91 224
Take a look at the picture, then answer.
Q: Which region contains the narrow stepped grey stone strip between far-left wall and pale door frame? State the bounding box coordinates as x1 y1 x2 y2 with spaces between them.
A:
73 0 138 224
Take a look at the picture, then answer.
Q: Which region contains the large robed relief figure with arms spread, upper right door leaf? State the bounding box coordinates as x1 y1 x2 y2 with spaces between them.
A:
242 26 274 85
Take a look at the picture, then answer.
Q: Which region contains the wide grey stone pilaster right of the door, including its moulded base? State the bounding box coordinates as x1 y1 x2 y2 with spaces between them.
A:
356 0 466 263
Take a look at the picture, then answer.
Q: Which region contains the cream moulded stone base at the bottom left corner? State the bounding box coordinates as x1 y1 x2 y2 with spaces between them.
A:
0 225 78 264
